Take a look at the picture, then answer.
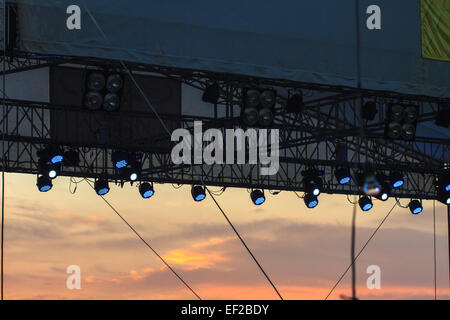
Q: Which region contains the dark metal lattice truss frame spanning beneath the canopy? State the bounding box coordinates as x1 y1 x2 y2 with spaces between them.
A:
0 52 450 199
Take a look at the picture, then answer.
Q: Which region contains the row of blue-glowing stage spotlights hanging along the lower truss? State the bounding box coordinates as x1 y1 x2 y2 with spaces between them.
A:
37 147 450 214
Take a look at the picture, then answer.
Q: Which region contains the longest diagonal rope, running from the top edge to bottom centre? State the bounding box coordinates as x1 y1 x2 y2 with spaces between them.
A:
83 1 283 300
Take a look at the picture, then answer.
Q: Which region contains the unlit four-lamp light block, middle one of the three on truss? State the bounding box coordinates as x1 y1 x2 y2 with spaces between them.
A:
241 88 277 127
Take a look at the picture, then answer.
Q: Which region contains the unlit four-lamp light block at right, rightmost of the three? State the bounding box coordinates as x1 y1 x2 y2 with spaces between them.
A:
385 103 419 141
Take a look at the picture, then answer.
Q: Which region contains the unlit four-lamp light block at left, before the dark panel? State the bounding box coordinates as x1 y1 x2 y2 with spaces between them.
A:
84 70 124 112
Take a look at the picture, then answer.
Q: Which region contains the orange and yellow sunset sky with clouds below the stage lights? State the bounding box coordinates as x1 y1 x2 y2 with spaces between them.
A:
0 174 449 299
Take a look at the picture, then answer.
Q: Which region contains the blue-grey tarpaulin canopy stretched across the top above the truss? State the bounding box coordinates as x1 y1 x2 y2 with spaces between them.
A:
6 0 450 98
